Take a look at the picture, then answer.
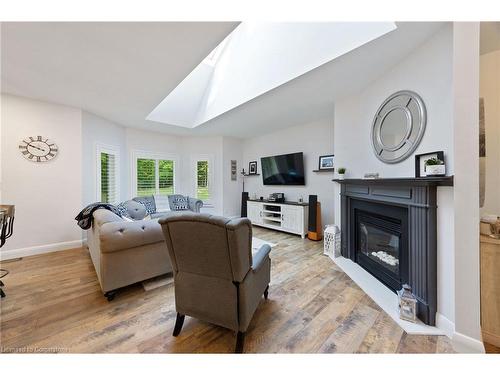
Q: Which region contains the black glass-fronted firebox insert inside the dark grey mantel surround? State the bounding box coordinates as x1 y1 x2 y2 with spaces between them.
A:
351 200 408 291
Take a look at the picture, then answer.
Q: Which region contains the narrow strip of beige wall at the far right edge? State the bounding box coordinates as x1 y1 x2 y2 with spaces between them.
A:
479 51 500 216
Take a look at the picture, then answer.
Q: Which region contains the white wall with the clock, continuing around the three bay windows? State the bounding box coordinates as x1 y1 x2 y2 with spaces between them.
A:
0 95 230 259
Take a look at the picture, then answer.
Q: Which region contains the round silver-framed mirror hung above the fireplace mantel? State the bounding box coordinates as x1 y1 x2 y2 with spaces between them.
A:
372 91 426 163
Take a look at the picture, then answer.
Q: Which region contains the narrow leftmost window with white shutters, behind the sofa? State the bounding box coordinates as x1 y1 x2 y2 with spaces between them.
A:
96 145 120 204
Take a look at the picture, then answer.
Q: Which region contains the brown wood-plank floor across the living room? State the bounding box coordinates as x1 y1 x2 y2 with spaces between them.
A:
0 228 453 353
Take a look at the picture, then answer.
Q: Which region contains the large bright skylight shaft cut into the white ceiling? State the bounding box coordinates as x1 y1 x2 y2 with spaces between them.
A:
147 22 396 128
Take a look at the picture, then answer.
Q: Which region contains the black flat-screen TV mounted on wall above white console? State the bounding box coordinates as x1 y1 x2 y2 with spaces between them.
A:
260 152 305 185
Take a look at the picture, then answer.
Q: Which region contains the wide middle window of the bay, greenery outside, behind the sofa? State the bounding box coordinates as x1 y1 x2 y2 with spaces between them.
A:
135 154 176 197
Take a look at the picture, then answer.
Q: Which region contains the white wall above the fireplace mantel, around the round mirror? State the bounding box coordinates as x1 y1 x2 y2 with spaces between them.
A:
335 25 453 177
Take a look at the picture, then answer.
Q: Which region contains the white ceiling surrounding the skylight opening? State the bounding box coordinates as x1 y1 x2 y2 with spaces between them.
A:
1 22 443 137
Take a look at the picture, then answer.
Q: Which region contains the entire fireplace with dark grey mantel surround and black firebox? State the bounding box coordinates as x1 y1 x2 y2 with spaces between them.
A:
334 177 453 325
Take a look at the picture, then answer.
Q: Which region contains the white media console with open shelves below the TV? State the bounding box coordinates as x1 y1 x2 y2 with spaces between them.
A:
247 200 309 238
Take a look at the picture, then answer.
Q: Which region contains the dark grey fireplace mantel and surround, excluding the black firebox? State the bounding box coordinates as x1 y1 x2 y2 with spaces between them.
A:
333 176 453 325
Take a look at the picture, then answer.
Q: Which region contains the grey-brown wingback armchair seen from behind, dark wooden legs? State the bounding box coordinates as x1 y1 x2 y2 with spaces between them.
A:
159 211 271 353
